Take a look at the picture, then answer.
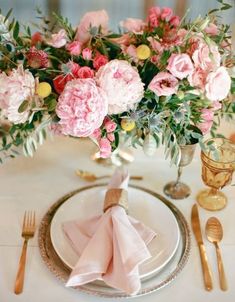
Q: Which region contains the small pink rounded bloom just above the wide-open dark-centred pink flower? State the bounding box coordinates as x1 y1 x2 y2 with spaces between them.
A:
167 53 194 80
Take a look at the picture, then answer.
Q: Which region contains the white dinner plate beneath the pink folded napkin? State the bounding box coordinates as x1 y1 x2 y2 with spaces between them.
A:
50 186 180 278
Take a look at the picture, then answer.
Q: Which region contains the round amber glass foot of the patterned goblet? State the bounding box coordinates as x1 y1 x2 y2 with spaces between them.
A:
197 189 227 211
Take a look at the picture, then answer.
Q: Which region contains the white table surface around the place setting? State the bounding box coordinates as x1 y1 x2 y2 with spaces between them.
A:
0 137 235 302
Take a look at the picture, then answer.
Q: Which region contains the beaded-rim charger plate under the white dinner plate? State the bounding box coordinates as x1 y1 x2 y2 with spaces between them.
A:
38 184 191 298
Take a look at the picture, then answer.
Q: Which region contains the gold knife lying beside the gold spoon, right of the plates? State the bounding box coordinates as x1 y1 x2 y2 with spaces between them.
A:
191 204 213 291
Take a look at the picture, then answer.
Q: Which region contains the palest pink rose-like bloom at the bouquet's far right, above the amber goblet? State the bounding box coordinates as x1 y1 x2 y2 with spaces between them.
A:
206 66 231 101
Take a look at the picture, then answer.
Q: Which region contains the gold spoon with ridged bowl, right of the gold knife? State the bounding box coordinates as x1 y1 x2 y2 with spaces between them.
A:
206 217 228 291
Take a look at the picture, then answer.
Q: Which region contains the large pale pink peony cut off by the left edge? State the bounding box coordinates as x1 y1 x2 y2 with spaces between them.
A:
0 66 35 124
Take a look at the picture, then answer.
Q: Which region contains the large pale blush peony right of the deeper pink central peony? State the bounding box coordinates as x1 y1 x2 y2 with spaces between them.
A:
96 60 144 114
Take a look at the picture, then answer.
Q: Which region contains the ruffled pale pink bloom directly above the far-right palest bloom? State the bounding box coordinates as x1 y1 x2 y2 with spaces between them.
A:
192 42 221 71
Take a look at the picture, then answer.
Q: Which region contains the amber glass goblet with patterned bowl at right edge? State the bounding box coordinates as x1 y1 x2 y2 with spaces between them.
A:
197 138 235 211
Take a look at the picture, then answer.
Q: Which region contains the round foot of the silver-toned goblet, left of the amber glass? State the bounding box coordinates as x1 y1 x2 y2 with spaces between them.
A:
163 181 191 199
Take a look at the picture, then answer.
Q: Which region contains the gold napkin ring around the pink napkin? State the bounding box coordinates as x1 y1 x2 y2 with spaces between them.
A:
104 188 128 212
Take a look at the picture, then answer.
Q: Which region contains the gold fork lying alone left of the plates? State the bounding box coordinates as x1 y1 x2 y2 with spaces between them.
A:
15 211 36 295
